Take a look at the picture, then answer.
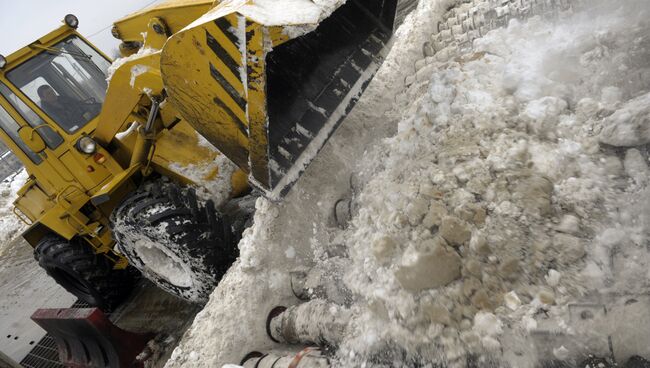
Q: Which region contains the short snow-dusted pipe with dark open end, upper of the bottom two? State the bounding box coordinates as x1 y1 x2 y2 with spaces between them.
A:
266 300 351 347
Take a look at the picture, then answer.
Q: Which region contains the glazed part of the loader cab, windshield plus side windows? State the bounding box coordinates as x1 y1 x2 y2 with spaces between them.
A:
0 35 110 154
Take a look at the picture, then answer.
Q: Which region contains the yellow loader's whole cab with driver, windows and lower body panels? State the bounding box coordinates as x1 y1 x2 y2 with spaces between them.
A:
0 18 119 221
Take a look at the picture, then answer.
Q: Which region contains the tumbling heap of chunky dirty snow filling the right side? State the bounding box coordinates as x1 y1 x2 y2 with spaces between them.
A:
339 1 650 366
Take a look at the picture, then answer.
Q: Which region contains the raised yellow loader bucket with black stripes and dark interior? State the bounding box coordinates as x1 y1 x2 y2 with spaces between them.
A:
161 0 417 198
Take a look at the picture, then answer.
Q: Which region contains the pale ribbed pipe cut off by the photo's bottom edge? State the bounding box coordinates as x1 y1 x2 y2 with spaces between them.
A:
241 347 330 368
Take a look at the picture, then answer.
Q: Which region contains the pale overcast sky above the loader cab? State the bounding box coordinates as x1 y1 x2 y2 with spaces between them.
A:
0 0 161 56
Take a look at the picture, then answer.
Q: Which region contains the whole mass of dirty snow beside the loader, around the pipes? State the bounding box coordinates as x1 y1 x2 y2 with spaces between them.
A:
167 0 650 367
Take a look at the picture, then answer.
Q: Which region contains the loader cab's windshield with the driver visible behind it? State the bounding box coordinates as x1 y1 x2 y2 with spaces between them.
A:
7 36 110 133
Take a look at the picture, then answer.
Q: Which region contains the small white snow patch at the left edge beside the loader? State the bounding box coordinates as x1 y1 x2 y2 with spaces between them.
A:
0 170 29 254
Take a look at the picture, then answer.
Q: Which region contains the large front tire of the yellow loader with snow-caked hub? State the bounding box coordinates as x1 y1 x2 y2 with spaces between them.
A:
111 180 250 303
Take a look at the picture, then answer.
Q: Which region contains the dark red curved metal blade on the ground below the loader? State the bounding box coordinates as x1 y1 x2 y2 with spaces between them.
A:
31 308 154 368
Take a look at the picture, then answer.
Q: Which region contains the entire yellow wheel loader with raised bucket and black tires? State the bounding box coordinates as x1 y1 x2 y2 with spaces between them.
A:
0 0 416 309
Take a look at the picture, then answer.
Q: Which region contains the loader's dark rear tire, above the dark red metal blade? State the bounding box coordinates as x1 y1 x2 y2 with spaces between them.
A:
34 235 137 312
